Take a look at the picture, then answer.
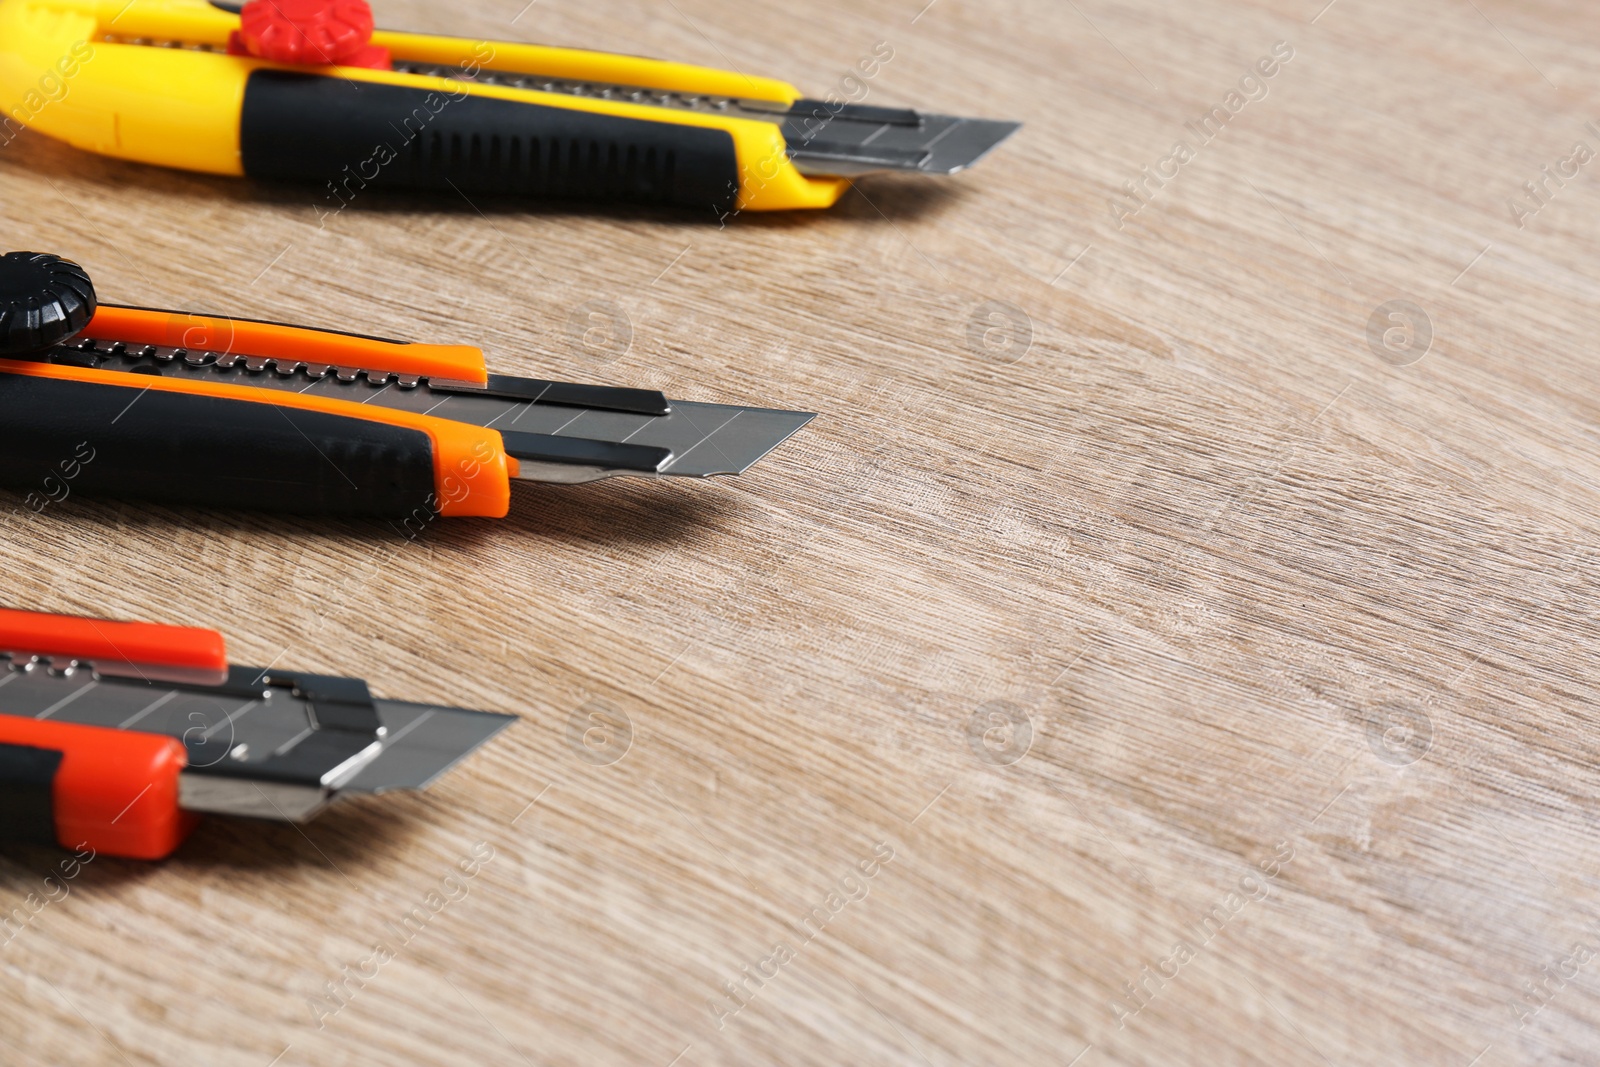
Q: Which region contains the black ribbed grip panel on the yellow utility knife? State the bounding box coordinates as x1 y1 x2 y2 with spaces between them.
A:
238 70 739 218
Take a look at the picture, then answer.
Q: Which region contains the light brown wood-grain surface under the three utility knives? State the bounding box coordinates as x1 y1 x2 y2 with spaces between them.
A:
0 0 1600 1067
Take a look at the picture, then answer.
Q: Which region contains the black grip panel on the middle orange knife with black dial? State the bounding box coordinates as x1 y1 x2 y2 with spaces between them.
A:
0 373 435 518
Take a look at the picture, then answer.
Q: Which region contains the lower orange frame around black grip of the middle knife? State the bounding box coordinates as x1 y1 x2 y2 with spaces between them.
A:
0 356 517 518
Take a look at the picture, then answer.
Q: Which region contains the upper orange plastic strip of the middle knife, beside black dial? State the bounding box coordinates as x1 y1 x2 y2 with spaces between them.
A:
80 304 488 386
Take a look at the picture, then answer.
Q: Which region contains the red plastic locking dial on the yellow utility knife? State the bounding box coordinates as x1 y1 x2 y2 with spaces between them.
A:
227 0 392 70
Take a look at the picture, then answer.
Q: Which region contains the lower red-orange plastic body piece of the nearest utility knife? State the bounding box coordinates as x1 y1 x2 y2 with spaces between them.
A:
0 716 197 859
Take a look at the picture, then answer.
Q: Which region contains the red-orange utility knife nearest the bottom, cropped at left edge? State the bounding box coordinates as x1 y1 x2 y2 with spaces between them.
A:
0 608 515 859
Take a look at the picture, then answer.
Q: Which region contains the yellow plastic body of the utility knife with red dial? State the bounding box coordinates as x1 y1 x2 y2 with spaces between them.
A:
0 0 850 211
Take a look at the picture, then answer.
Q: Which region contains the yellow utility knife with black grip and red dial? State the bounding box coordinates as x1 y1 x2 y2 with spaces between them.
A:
0 0 1018 218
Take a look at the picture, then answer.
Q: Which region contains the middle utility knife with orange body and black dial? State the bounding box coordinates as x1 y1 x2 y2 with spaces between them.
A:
0 253 813 522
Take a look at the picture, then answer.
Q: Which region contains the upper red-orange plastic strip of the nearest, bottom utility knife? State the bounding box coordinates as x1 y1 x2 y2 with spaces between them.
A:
0 608 227 685
